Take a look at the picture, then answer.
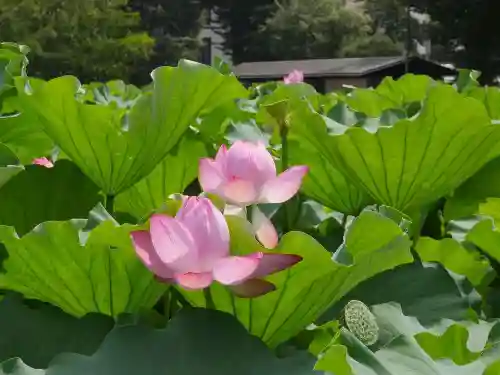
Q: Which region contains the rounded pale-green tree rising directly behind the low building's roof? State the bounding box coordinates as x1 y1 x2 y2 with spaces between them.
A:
260 0 399 60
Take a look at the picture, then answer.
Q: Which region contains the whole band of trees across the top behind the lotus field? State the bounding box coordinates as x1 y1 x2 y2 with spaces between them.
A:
0 0 500 85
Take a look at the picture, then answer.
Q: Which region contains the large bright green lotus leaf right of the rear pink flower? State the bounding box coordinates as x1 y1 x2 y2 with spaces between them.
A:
294 85 500 211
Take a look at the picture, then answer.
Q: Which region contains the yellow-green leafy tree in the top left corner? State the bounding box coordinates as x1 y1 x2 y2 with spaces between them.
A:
0 0 153 81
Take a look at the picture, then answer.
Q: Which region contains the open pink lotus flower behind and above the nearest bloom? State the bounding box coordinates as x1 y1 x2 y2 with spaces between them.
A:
199 141 308 206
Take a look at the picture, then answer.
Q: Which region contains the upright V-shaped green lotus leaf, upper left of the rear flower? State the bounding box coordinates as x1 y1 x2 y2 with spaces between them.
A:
18 60 246 196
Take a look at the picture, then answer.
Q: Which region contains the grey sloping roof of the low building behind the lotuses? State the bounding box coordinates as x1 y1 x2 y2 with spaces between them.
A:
233 56 455 79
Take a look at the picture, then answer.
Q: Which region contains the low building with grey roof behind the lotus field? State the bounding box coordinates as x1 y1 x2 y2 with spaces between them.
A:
233 56 457 92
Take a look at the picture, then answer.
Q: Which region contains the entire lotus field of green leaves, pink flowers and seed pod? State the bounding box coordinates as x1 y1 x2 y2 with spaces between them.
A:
0 44 500 375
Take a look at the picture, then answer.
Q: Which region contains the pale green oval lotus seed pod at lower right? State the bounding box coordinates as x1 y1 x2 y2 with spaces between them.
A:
340 300 379 346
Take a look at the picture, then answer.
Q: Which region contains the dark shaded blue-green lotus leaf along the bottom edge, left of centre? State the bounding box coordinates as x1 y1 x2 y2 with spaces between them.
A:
1 309 315 375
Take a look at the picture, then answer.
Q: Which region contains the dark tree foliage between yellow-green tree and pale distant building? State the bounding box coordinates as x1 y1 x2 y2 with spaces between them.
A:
129 0 204 83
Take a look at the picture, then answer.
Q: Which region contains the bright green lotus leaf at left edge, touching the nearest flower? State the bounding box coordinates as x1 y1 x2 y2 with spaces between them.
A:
0 210 166 316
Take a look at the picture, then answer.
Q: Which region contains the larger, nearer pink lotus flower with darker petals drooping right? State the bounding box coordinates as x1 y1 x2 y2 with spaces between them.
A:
131 197 302 297
